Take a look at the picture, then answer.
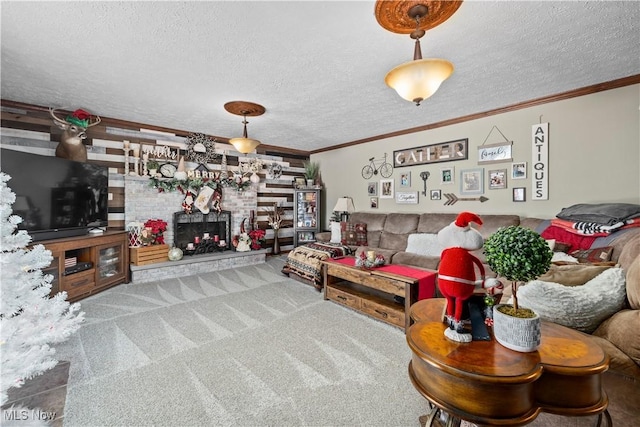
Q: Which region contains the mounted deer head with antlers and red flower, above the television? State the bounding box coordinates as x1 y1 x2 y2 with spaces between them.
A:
49 108 101 162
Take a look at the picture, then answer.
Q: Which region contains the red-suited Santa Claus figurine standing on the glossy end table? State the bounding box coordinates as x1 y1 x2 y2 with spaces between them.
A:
438 212 502 342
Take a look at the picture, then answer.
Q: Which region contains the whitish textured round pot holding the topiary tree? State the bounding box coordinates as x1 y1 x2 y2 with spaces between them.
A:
493 304 540 353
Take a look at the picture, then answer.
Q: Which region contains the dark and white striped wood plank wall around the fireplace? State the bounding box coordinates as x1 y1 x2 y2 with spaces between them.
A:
0 100 309 250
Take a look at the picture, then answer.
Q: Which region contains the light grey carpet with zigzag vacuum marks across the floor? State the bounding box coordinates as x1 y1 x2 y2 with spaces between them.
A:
58 257 427 427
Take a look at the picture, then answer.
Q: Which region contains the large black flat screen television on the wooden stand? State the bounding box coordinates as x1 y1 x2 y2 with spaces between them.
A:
0 148 109 242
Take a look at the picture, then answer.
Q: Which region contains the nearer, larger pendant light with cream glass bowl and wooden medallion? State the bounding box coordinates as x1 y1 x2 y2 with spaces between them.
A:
375 0 462 105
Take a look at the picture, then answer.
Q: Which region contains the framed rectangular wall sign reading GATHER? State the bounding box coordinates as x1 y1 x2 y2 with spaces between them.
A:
393 138 469 168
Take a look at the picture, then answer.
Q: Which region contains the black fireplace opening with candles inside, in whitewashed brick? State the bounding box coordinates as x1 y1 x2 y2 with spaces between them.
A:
173 211 231 254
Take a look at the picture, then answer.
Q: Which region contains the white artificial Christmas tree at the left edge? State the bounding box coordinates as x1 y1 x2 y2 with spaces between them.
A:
0 172 84 403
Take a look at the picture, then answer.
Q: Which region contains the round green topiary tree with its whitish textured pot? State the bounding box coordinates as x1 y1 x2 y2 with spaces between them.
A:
484 226 553 352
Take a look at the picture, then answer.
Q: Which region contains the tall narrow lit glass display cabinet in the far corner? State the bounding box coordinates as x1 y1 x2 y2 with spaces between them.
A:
293 189 321 246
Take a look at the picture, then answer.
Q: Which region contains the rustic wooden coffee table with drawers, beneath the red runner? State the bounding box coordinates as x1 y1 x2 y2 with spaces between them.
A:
322 257 436 331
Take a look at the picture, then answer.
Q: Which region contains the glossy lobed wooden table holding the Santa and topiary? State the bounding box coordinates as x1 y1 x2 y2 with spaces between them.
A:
407 298 612 426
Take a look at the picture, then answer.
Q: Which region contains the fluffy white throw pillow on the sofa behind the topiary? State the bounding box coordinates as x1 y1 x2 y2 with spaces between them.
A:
518 268 626 333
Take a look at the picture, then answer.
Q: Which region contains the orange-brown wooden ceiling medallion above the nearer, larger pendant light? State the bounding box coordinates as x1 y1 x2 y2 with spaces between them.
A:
375 0 462 34
